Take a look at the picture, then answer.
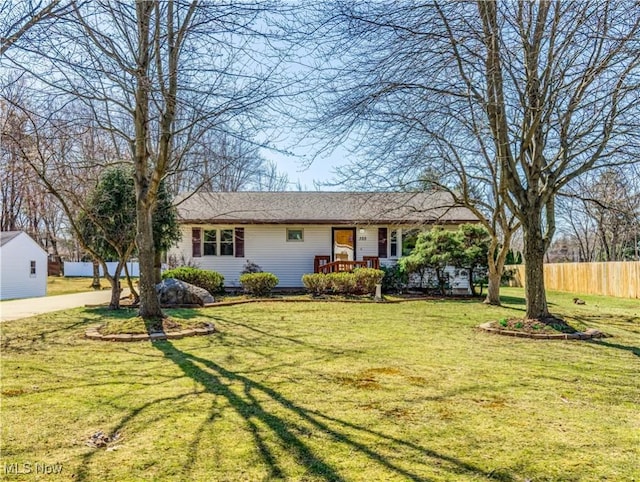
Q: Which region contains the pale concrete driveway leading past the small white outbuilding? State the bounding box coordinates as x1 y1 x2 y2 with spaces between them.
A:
0 290 122 322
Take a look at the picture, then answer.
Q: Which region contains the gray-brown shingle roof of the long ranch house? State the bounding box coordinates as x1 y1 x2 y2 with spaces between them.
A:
177 192 477 224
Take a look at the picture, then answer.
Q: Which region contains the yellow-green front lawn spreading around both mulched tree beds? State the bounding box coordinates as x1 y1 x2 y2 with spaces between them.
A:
0 289 640 482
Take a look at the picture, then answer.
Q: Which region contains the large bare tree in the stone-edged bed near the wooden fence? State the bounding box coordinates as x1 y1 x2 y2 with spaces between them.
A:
304 0 640 319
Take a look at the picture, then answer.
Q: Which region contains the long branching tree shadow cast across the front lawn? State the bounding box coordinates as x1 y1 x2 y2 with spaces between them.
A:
154 341 513 481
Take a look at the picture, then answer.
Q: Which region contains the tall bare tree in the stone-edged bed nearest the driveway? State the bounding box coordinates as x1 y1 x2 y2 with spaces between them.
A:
1 0 288 318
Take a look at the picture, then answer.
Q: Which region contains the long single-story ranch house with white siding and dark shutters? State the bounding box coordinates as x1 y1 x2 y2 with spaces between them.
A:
169 192 477 288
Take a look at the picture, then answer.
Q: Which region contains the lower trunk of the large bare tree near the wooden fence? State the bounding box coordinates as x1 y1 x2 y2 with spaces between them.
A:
522 219 549 320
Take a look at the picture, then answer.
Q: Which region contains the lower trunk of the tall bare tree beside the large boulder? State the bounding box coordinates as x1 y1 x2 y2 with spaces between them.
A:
136 201 164 319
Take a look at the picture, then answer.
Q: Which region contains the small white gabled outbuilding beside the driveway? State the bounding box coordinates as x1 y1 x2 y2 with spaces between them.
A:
0 231 47 300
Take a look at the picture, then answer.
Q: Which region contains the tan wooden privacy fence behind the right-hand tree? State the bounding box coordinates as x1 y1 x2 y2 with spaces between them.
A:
505 261 640 298
